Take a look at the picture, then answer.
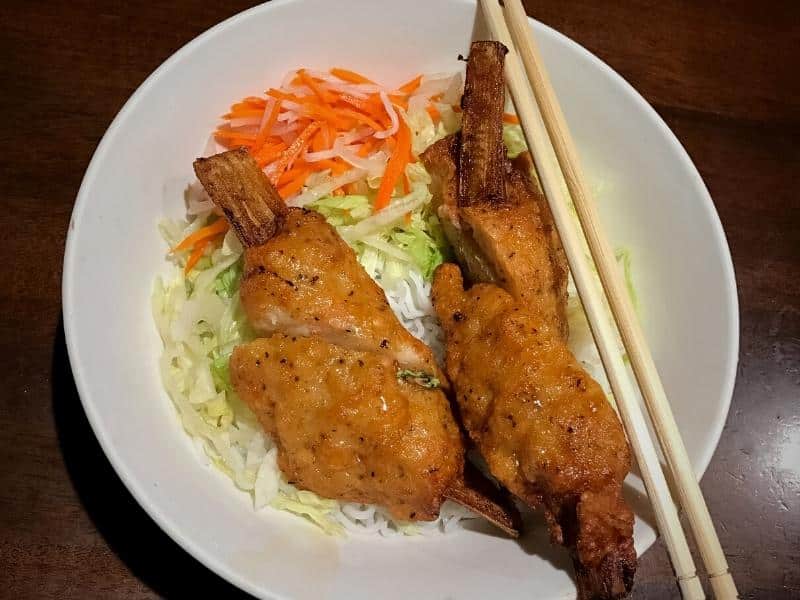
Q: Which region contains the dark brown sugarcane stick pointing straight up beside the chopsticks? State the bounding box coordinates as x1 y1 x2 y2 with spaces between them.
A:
458 42 507 206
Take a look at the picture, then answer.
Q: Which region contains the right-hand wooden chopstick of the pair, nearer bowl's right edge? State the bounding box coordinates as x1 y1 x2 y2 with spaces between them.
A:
505 0 737 599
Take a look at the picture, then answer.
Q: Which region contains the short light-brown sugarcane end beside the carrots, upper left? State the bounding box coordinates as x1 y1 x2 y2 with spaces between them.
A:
194 148 286 247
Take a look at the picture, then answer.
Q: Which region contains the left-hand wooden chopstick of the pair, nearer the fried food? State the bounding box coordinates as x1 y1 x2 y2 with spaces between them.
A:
480 0 728 599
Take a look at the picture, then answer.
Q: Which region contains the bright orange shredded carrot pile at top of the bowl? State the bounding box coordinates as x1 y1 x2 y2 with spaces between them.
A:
214 67 442 204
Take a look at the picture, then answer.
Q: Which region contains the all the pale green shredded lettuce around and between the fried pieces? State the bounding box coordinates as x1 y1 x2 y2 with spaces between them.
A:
152 76 636 536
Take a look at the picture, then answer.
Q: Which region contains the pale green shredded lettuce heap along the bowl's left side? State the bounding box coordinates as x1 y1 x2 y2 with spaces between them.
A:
152 216 343 534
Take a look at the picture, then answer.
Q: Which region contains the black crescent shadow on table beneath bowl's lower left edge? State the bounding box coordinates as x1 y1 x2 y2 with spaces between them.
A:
52 321 251 599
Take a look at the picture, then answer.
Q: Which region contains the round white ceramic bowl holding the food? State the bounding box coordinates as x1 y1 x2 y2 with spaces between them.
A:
63 0 738 599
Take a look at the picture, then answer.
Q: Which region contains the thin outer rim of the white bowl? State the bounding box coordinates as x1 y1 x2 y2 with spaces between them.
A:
62 0 740 600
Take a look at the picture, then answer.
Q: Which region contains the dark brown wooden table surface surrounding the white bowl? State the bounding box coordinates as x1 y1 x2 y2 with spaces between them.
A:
0 0 800 599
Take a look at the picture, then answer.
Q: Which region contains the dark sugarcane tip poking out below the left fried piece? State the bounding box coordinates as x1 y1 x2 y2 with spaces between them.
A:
444 462 522 538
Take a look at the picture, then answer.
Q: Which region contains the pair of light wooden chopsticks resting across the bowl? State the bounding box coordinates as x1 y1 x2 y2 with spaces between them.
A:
480 0 738 600
